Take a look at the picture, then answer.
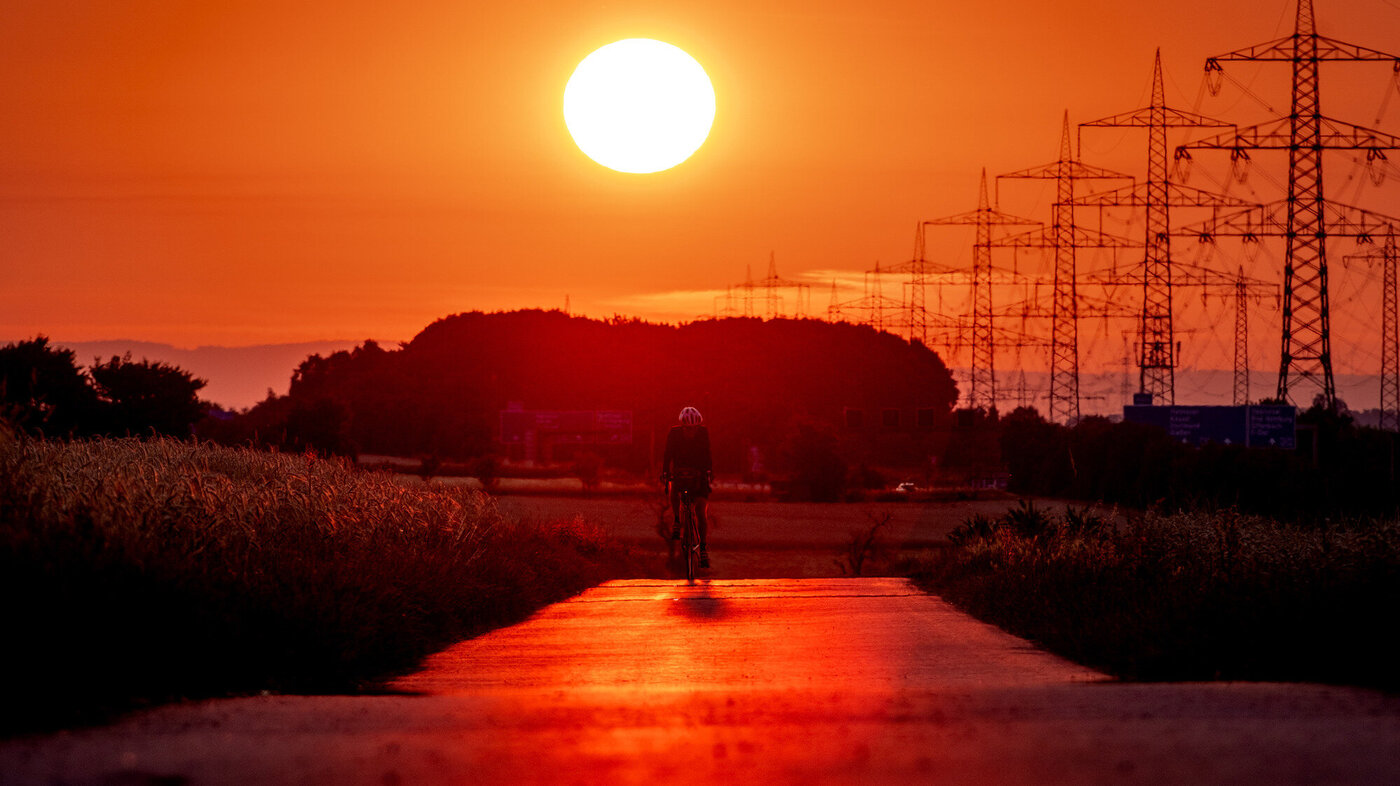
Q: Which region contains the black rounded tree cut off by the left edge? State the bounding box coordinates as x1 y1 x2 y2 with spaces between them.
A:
0 336 98 437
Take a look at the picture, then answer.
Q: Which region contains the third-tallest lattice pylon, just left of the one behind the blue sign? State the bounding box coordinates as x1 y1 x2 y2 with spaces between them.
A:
997 112 1133 423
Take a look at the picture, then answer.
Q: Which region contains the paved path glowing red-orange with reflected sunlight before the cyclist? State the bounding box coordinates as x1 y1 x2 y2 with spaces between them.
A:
0 579 1400 786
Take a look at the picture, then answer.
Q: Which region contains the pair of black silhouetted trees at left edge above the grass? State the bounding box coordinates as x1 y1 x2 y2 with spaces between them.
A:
0 336 209 437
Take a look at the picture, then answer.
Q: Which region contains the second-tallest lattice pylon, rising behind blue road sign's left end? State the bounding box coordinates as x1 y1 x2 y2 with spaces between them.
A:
1078 49 1252 404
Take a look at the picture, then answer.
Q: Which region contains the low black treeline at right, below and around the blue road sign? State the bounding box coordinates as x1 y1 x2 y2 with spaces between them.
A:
997 406 1400 518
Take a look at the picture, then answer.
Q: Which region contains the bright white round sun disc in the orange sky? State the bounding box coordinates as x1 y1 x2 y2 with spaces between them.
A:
564 38 714 174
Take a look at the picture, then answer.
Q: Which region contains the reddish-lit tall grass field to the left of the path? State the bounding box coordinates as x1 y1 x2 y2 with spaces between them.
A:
0 433 641 729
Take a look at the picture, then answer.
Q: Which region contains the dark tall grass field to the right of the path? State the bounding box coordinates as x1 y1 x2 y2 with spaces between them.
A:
910 506 1400 689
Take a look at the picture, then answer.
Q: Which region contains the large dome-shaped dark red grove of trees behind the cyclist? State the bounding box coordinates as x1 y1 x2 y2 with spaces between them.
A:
203 311 956 472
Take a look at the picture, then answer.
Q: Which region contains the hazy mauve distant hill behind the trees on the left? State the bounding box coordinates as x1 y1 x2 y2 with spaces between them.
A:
45 339 375 409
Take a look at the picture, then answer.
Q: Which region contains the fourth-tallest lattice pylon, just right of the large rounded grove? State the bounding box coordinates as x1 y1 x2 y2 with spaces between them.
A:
920 167 1040 411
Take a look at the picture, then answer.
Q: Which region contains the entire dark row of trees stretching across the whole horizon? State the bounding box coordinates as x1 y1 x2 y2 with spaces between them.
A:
10 311 1400 516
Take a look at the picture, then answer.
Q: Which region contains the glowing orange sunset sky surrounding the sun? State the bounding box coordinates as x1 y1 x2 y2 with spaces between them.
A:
0 0 1400 386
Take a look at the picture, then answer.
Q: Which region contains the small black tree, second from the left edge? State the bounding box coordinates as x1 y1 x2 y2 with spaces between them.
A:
90 353 209 437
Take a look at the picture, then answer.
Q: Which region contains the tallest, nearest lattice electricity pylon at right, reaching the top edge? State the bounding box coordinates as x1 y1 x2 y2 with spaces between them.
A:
1179 0 1400 408
